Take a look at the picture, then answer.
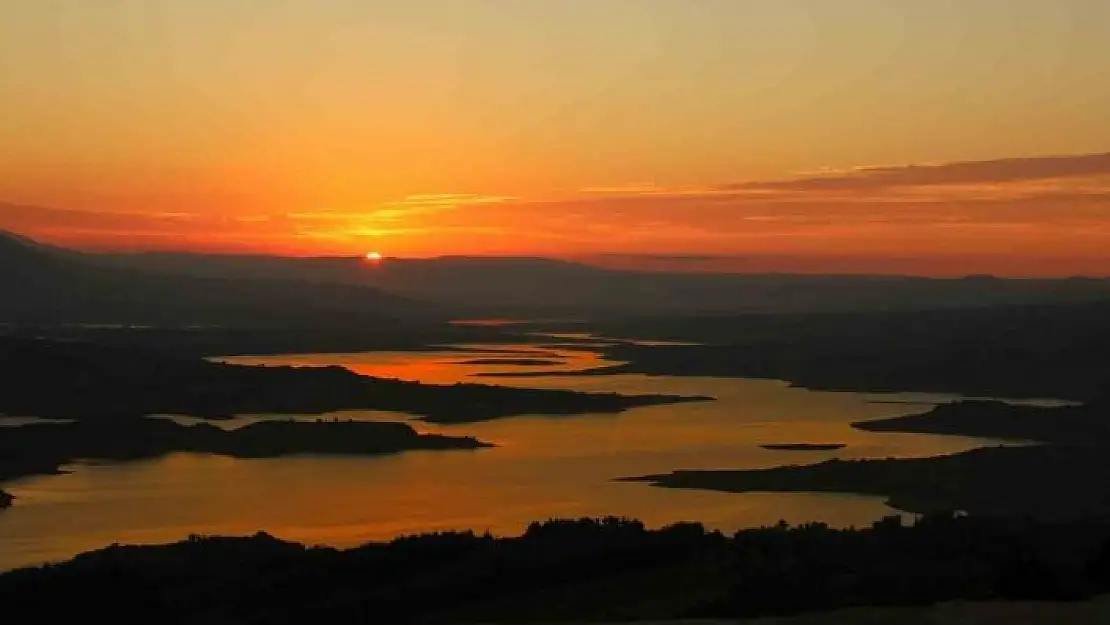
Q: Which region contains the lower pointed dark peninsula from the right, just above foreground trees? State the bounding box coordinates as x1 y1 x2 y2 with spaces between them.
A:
627 445 1110 520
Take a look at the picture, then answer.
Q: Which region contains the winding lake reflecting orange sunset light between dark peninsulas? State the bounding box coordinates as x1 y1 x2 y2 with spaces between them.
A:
0 335 1038 569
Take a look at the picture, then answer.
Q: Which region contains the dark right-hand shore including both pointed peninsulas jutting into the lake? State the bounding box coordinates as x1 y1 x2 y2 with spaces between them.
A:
628 401 1110 518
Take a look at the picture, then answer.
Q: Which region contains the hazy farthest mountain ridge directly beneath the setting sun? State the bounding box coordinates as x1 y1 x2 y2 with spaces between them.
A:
88 248 1110 317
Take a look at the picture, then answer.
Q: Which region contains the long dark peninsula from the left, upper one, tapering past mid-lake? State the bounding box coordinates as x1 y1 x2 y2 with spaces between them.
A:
0 336 709 423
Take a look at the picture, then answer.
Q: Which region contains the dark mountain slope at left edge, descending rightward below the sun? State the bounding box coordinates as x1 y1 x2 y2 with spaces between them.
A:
0 232 436 326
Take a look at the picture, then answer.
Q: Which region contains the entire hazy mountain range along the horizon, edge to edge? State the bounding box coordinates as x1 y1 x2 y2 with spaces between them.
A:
0 233 1110 327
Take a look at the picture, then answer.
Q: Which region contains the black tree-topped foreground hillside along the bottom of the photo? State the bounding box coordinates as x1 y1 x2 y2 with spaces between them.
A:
0 515 1110 625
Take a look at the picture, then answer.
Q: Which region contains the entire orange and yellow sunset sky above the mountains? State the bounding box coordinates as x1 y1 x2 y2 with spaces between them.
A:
0 0 1110 275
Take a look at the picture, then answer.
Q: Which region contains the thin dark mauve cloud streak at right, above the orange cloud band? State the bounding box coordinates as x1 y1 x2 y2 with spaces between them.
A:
724 153 1110 191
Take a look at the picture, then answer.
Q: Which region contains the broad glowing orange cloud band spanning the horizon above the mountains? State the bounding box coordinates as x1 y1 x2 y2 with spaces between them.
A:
0 154 1110 264
